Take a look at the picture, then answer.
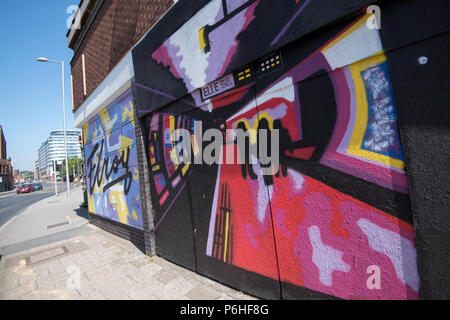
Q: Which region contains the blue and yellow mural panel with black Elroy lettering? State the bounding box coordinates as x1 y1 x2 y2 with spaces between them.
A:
83 89 143 229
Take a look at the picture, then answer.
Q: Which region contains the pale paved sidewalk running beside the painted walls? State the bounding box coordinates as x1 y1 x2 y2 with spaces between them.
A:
0 188 255 300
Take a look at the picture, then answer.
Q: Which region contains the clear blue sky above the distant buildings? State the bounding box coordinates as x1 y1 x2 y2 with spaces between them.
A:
0 0 79 171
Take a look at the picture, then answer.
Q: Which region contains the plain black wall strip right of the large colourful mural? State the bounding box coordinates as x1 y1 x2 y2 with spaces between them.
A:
383 1 450 299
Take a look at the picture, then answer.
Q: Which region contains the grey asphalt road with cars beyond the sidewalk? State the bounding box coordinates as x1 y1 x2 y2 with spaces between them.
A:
0 183 72 228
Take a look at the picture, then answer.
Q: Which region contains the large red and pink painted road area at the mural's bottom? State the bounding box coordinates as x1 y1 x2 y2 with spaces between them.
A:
216 165 415 299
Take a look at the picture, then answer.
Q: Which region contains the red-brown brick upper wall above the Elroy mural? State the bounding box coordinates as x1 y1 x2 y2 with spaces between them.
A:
71 0 173 112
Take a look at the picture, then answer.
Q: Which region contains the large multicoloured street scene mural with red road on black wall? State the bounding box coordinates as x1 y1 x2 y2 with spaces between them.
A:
134 0 420 299
